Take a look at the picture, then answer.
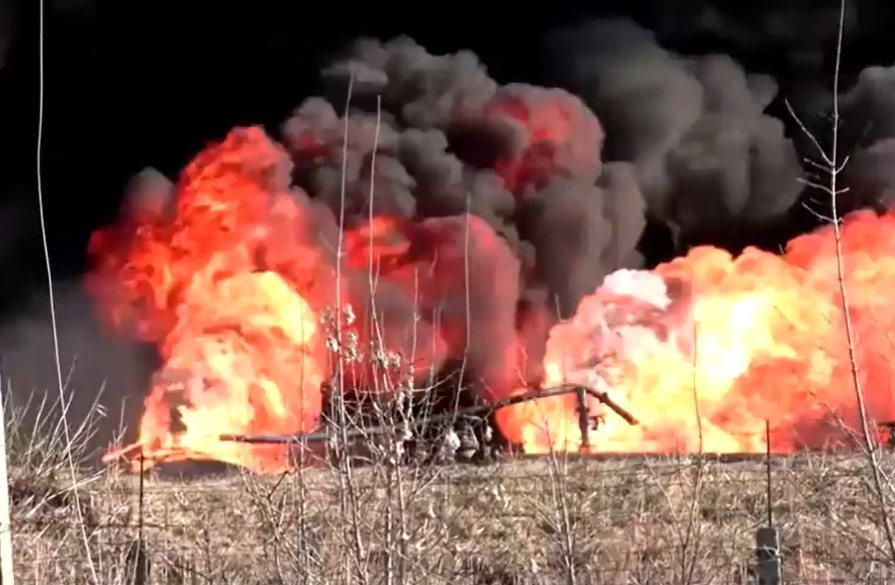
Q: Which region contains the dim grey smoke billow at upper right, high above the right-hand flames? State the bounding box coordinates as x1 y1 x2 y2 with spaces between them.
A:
547 19 802 240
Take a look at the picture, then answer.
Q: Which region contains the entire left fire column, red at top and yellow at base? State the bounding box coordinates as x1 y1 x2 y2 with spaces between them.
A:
87 130 326 472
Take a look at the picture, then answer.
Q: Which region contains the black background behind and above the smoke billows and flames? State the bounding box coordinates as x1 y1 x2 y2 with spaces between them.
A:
0 0 895 452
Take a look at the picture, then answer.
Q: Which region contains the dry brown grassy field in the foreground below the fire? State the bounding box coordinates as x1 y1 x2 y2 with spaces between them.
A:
13 448 895 585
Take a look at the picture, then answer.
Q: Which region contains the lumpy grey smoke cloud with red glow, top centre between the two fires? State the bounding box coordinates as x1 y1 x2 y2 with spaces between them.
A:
283 37 645 313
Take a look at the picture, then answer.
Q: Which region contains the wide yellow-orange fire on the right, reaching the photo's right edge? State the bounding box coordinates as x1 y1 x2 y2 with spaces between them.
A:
501 217 895 453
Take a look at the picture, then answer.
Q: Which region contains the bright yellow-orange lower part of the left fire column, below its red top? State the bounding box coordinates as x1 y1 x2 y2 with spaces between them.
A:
109 272 324 472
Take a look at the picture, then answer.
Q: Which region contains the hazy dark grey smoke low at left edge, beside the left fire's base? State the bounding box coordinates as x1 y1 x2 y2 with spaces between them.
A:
0 283 155 461
